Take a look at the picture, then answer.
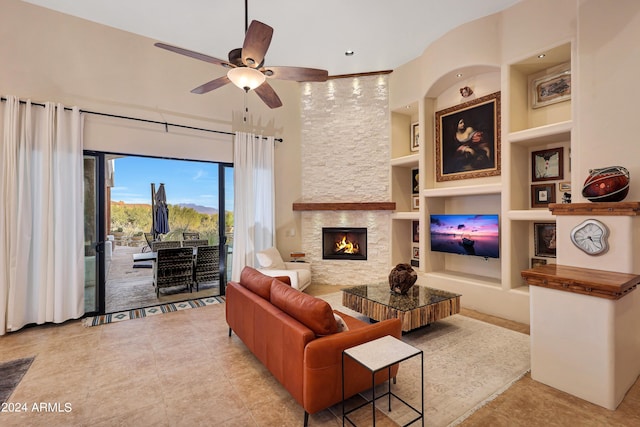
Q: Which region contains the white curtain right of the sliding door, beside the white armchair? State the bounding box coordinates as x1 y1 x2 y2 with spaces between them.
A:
231 132 275 281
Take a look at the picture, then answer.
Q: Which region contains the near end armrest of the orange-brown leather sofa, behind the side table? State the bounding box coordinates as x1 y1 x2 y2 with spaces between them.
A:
304 319 402 414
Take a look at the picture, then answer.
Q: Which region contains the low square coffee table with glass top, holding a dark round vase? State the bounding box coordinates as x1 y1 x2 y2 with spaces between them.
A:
342 283 461 332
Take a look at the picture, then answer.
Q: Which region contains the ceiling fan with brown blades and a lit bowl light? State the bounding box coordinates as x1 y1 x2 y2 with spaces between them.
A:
155 5 328 108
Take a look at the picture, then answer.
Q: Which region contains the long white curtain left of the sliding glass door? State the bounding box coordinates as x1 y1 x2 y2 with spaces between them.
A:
0 96 84 335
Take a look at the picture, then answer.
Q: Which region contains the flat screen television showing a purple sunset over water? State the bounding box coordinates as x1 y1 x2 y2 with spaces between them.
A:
430 214 500 258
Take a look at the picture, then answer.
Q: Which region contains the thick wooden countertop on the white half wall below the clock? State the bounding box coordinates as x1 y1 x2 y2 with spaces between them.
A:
521 264 640 300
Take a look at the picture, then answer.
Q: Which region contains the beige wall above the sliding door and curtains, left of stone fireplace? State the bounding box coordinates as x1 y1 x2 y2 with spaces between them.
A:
0 0 301 251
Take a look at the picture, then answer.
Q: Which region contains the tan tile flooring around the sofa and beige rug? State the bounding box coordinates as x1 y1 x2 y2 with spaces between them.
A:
0 286 640 426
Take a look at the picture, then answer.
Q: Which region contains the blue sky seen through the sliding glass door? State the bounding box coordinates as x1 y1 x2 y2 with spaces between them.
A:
111 156 233 210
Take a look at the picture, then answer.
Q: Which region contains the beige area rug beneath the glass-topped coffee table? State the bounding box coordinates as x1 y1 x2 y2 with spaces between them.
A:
320 292 531 427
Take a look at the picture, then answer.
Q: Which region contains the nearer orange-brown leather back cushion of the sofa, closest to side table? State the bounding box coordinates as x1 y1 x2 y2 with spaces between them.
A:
271 280 338 335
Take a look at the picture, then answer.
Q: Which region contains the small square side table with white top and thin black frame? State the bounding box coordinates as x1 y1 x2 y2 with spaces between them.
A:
342 335 424 426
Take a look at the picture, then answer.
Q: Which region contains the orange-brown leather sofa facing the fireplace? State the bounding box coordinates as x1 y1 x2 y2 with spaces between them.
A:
226 267 402 426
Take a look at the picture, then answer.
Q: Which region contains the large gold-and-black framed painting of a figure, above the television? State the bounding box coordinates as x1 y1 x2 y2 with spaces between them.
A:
435 92 500 182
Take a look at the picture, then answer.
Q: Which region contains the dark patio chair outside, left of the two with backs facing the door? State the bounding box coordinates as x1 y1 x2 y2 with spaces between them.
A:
153 247 193 297
